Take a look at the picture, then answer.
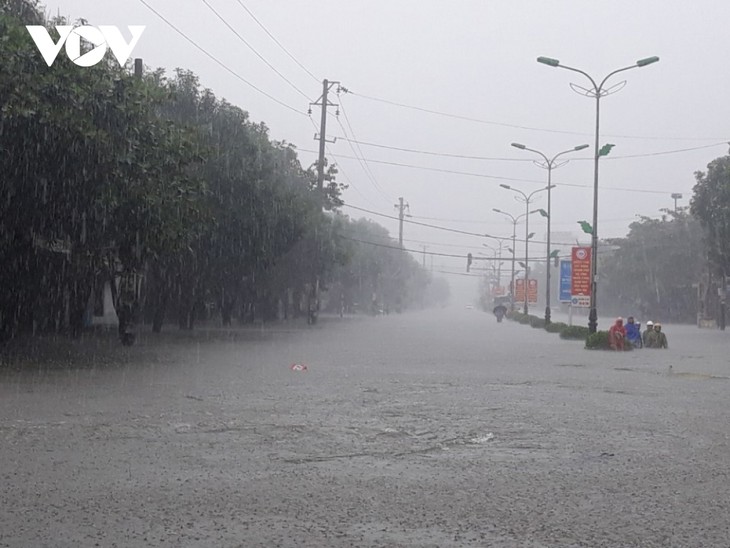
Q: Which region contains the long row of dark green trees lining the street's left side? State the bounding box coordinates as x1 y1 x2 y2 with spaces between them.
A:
0 4 438 337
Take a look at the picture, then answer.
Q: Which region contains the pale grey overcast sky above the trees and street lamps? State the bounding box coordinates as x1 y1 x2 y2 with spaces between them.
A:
38 0 730 300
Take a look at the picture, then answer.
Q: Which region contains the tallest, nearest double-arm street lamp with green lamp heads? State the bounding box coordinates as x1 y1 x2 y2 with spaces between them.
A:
537 57 659 333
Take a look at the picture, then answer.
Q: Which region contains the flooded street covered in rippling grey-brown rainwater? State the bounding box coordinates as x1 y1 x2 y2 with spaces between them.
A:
0 309 730 547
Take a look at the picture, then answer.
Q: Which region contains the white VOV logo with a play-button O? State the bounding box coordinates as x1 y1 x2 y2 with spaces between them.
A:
25 25 145 67
